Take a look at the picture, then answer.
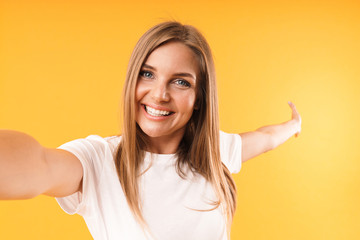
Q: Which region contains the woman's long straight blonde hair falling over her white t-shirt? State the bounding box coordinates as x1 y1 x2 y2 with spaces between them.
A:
115 22 236 237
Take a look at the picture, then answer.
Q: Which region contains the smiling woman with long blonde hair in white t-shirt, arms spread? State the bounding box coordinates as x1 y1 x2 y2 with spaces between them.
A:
0 22 301 240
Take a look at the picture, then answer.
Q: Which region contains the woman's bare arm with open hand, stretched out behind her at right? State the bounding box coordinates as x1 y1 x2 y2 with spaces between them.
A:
240 102 301 162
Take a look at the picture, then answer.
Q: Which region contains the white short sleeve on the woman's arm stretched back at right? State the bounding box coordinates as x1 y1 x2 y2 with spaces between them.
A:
220 131 242 173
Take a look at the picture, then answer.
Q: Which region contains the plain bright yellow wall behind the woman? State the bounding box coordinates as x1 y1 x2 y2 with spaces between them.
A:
0 0 360 240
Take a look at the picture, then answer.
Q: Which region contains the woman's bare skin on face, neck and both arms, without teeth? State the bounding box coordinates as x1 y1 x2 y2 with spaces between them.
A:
0 42 301 199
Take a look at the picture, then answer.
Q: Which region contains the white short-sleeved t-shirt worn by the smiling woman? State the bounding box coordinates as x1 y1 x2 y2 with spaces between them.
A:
57 132 241 240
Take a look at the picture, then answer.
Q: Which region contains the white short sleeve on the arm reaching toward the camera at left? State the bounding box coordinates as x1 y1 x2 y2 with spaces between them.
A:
56 135 112 216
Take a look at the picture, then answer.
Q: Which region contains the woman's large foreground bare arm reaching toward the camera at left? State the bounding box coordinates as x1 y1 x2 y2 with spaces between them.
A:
0 130 82 199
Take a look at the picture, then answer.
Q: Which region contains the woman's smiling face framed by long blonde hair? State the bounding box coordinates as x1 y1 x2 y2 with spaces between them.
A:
135 42 199 144
